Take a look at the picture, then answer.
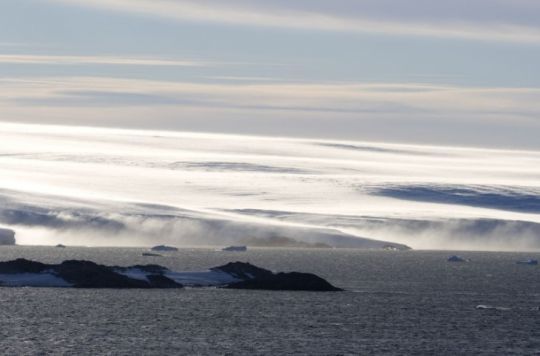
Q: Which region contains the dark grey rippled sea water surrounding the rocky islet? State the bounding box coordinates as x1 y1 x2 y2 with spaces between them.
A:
0 247 540 355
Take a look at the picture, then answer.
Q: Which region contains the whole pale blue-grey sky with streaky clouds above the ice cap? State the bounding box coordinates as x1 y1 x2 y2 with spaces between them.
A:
0 0 540 149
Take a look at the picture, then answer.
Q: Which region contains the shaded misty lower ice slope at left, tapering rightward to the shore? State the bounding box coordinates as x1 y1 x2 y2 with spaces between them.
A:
0 190 394 248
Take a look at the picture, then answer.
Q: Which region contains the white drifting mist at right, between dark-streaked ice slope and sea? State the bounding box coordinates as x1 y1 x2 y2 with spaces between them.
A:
234 209 540 251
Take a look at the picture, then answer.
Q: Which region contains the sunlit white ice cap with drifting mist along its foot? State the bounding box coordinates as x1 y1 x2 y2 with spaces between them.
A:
0 124 540 250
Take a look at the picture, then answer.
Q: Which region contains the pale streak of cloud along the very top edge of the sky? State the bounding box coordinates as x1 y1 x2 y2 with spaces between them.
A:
49 0 540 43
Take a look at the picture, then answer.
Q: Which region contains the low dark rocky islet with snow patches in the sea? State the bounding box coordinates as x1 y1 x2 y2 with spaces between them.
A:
0 259 341 291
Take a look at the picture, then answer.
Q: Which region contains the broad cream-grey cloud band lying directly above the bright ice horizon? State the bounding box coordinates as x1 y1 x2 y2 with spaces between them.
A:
0 77 540 147
